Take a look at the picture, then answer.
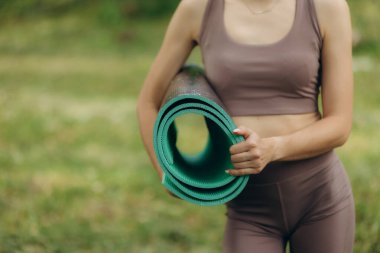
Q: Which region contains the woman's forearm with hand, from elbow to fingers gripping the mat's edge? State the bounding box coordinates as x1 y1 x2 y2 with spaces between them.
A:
226 113 352 176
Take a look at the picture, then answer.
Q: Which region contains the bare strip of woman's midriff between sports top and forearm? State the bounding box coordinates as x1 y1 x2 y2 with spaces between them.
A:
232 112 321 138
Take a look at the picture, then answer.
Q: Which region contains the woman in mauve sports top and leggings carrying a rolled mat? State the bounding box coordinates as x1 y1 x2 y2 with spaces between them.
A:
137 0 355 253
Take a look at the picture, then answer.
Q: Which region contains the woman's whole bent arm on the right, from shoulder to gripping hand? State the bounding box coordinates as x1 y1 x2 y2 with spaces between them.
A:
228 0 353 176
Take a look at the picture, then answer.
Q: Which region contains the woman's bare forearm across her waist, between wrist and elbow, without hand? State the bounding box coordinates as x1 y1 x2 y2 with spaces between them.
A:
267 116 351 161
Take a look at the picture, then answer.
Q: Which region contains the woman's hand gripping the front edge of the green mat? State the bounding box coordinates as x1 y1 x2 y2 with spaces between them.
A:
226 126 276 176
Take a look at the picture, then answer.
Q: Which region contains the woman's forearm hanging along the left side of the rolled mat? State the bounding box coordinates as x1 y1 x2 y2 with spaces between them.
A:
136 102 163 179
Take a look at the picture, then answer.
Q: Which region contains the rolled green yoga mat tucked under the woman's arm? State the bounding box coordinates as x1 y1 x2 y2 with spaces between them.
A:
153 64 248 206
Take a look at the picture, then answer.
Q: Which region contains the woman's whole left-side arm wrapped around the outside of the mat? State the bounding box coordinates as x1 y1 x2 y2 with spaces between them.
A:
136 0 199 178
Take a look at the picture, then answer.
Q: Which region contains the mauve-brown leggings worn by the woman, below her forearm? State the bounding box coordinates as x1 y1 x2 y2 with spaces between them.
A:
223 151 355 253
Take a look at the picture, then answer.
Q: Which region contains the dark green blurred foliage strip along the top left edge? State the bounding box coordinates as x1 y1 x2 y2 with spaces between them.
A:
0 0 180 24
